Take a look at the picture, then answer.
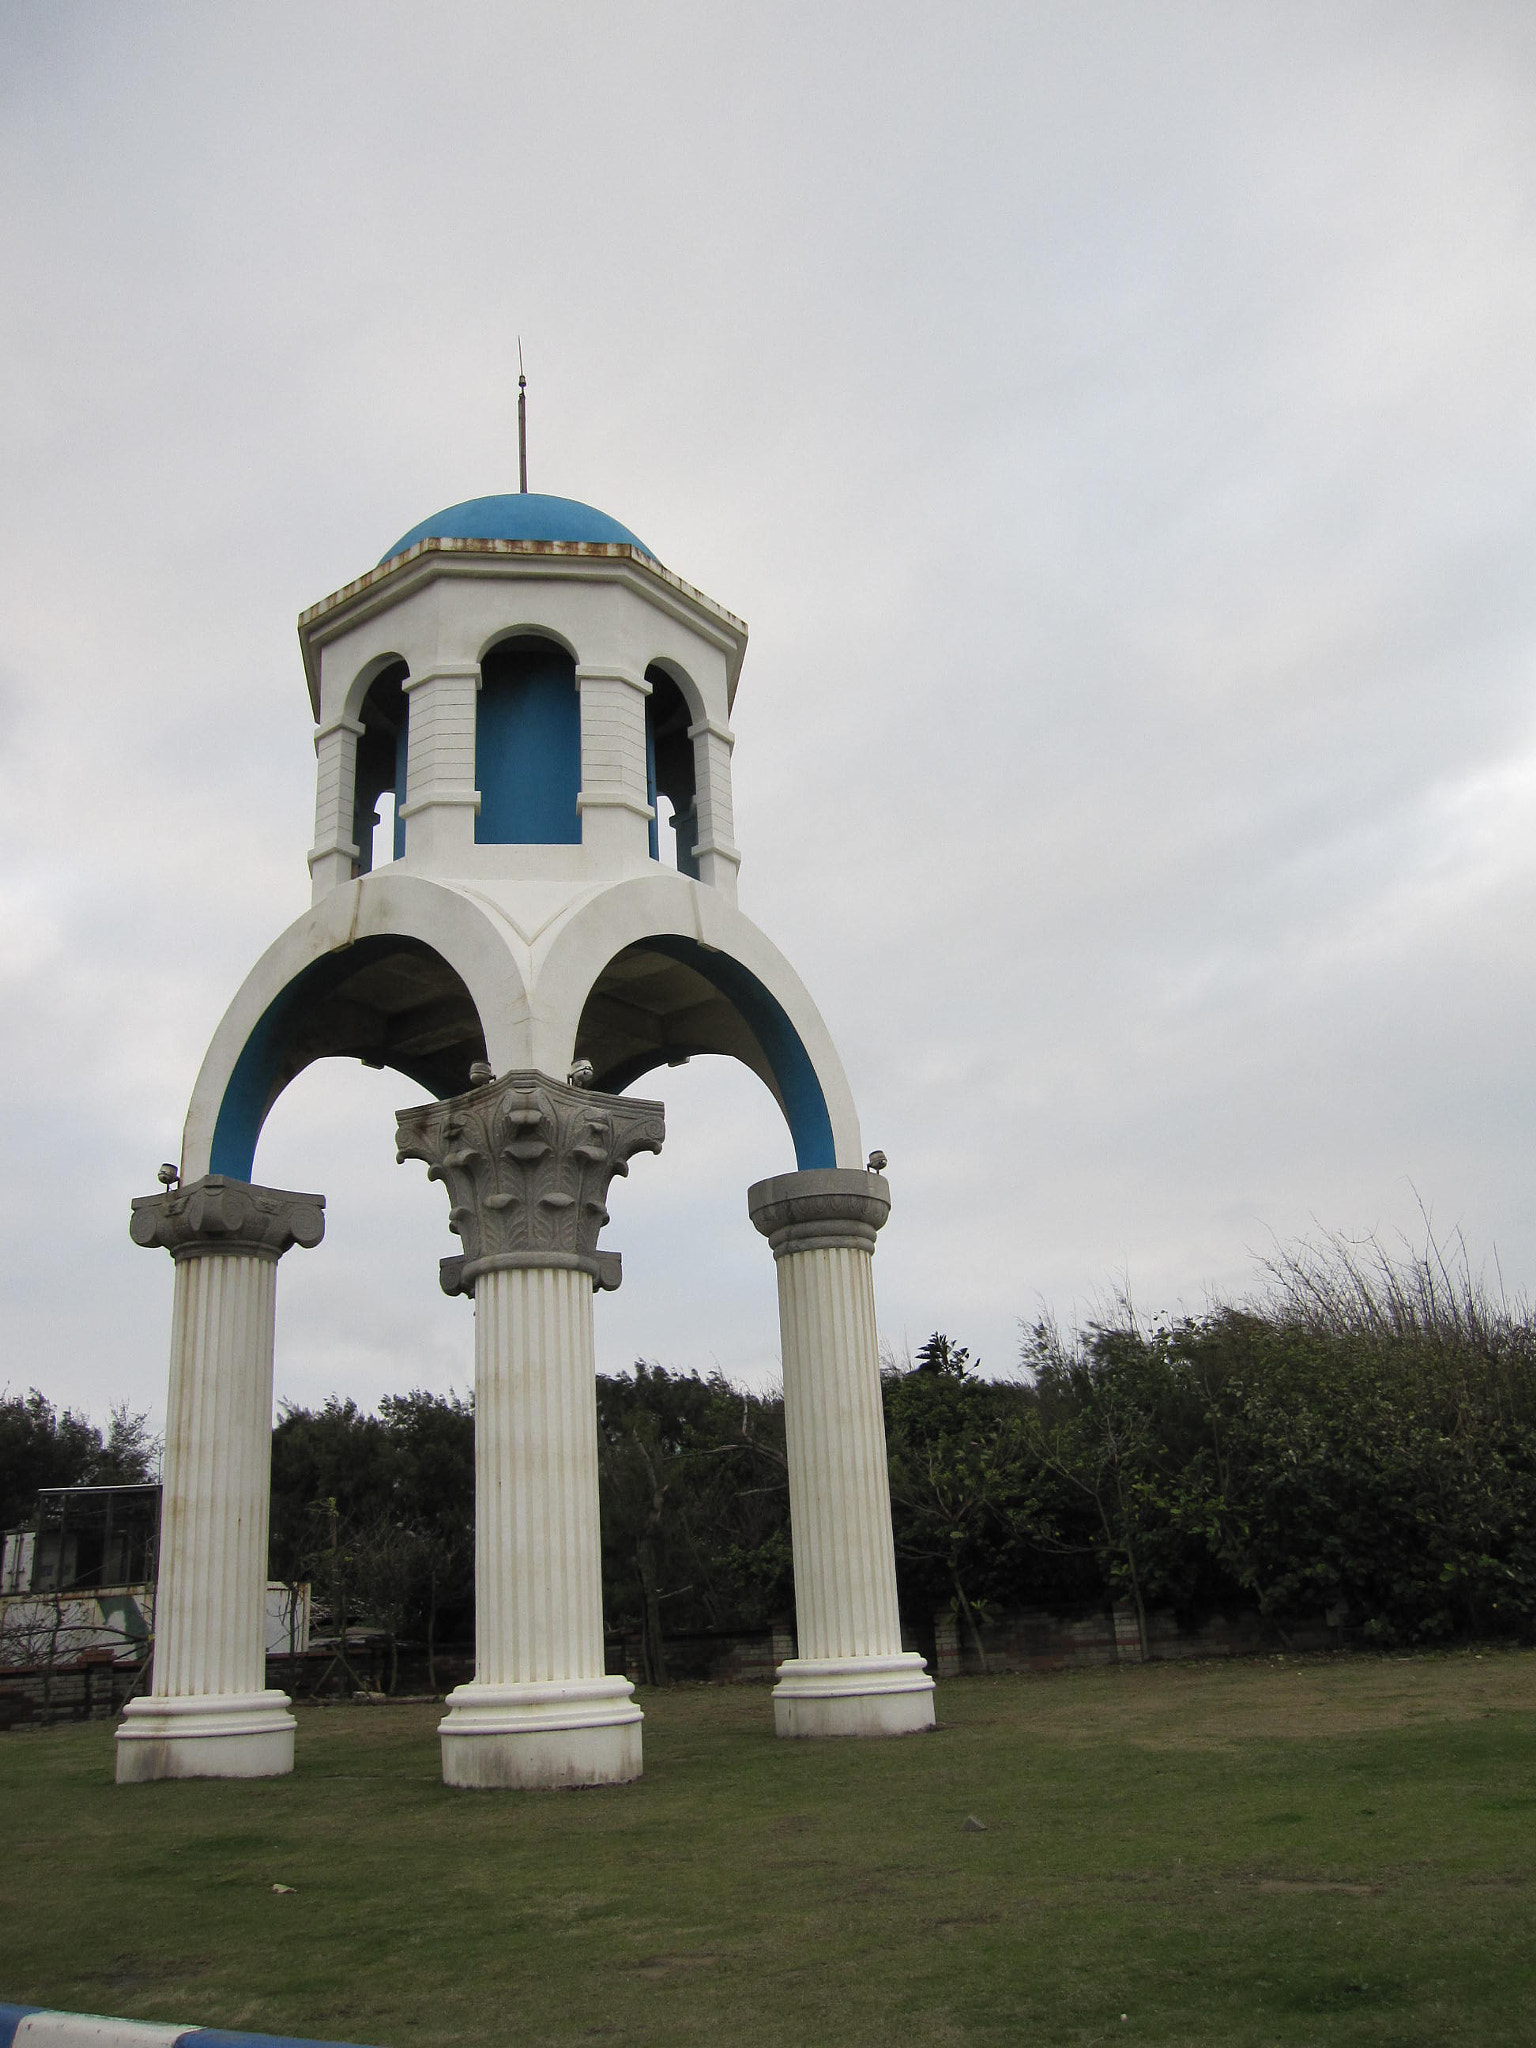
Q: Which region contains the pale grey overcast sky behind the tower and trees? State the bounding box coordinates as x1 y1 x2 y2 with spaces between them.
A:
0 0 1536 1417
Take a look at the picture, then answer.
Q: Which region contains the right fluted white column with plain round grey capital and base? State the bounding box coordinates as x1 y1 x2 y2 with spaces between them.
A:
748 1167 934 1735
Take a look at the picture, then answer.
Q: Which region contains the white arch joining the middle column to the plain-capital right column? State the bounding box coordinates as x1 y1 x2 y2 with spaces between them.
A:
532 870 864 1167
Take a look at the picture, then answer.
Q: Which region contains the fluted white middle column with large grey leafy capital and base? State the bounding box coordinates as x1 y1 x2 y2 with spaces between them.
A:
397 1071 666 1786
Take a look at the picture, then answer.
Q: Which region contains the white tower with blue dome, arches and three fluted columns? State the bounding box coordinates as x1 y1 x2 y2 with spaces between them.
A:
117 492 934 1786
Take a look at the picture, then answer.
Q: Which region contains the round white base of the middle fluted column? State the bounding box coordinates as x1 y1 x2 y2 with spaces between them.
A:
438 1677 643 1792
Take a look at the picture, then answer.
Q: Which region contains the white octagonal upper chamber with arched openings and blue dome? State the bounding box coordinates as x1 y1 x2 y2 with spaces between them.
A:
299 492 748 901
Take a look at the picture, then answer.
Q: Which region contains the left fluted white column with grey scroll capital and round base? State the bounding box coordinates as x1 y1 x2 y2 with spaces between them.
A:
117 1174 326 1784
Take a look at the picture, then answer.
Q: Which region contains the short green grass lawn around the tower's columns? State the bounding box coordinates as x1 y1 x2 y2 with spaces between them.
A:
0 1653 1536 2048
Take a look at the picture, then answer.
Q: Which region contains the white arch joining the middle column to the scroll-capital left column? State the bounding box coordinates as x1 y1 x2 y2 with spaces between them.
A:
182 872 530 1182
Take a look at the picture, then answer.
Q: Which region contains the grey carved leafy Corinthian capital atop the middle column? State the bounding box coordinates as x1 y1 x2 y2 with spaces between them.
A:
395 1071 666 1294
